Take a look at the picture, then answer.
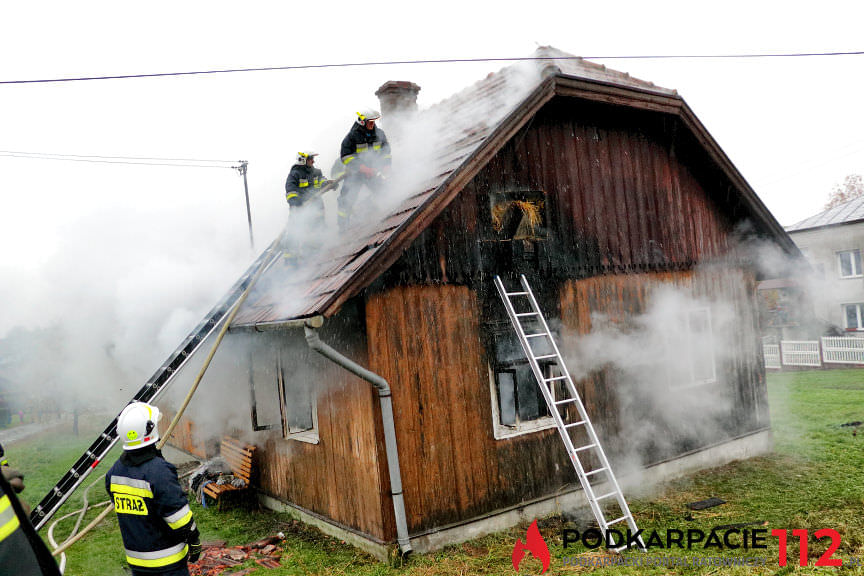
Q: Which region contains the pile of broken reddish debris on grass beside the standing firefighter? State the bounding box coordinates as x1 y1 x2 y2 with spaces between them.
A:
189 532 285 576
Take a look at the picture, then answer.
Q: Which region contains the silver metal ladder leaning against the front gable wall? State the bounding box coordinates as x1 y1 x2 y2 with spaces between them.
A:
495 275 645 551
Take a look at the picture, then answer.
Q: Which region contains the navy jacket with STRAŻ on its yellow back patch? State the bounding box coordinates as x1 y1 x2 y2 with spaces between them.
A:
105 446 199 574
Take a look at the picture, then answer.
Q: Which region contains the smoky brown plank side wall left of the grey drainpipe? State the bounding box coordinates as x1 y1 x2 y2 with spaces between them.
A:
166 318 395 542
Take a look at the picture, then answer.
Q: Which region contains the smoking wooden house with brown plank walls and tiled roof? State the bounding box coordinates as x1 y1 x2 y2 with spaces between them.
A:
160 48 795 556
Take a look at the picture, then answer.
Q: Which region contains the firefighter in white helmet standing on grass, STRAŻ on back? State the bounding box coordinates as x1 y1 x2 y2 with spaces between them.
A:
105 402 201 576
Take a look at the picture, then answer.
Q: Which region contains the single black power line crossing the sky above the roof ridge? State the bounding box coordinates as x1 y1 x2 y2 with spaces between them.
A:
0 51 864 85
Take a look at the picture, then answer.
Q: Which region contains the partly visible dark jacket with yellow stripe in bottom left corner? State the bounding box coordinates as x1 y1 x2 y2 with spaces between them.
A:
0 474 60 576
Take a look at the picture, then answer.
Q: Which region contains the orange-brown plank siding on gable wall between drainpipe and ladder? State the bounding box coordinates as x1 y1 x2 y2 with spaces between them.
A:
366 286 575 534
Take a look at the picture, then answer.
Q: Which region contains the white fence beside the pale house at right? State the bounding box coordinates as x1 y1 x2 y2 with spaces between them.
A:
762 336 864 370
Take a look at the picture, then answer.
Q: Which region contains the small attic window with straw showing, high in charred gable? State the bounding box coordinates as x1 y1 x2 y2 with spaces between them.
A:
489 190 547 241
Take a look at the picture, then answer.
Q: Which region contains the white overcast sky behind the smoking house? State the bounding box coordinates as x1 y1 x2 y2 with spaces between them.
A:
0 0 864 396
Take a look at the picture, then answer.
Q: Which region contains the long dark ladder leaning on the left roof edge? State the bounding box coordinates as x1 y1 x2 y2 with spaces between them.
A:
30 235 282 530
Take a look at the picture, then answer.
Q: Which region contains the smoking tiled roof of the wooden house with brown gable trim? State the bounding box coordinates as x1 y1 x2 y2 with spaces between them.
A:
234 47 794 326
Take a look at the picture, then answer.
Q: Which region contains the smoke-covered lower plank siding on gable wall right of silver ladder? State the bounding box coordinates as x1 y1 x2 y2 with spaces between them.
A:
560 266 769 465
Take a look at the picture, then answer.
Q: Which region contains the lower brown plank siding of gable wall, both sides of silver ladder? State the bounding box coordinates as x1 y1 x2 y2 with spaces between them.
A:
366 269 768 534
